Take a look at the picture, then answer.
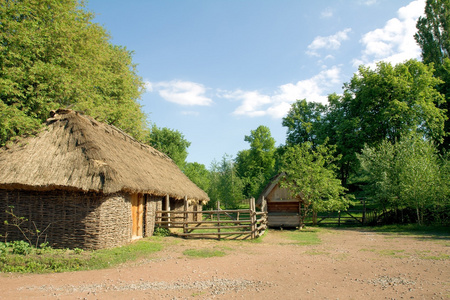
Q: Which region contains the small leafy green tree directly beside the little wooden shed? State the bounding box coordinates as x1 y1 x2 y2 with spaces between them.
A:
281 142 349 227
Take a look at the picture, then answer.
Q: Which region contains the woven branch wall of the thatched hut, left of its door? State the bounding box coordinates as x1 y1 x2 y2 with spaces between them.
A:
0 190 131 249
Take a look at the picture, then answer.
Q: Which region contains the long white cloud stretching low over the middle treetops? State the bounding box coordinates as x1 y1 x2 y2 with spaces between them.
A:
227 66 341 118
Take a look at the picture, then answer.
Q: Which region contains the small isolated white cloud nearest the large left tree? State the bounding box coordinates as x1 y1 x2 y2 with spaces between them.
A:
145 80 213 106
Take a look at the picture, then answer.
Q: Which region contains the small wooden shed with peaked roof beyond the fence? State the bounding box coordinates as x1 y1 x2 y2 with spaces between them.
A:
256 173 302 227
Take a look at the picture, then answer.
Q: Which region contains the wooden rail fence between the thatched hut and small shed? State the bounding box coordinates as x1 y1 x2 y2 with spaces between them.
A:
155 198 267 240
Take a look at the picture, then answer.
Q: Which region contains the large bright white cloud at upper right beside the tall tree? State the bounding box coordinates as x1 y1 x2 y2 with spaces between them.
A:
353 0 425 66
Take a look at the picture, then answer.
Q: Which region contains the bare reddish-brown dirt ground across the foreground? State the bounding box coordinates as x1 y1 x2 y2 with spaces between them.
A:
0 229 450 299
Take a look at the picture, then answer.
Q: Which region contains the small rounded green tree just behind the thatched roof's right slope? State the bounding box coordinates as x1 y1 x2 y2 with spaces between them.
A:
146 125 191 169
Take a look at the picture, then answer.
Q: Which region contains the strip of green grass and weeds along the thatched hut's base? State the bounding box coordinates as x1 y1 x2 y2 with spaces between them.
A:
0 238 163 273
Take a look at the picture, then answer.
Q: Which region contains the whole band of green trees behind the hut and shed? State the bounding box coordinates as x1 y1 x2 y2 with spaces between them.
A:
0 0 450 224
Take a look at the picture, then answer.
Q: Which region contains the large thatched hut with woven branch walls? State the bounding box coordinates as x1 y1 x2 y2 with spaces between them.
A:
0 110 209 249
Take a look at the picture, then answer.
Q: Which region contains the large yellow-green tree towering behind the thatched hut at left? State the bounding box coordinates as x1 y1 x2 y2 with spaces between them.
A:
0 0 147 144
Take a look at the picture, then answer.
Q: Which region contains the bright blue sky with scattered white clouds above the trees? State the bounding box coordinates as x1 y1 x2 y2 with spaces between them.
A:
86 0 425 168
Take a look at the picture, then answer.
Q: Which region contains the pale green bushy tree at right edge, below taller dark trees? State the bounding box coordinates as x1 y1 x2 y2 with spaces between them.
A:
358 135 450 224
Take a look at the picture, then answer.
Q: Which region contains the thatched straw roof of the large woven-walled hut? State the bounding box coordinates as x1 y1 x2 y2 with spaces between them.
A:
0 110 209 200
